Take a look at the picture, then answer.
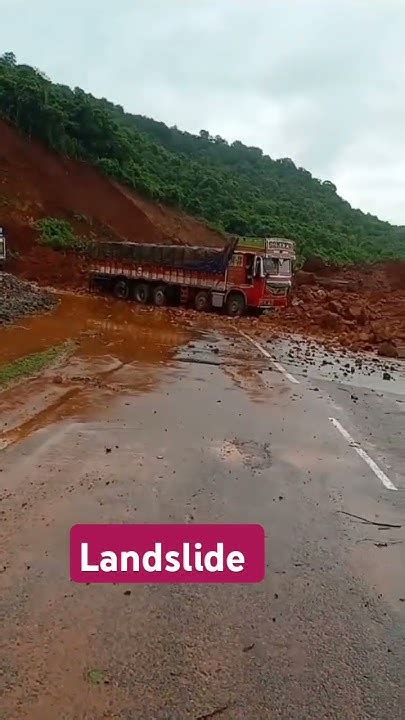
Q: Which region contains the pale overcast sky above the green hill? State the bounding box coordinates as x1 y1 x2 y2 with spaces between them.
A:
0 0 405 224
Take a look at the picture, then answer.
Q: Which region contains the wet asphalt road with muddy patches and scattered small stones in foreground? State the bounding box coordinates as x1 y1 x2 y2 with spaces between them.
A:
0 296 405 720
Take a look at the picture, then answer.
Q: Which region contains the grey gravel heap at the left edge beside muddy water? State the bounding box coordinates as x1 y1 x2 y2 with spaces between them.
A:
0 272 58 325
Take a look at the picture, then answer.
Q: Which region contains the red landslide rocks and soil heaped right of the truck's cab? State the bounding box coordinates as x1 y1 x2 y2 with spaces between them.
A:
278 262 405 358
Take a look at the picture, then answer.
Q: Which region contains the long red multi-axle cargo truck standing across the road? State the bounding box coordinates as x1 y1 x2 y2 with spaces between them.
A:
89 237 295 316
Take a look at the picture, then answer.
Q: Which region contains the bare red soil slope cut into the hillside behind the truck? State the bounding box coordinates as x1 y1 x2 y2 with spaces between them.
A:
0 120 224 287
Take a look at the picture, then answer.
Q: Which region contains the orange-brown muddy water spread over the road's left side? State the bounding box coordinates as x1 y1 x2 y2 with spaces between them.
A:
0 294 195 450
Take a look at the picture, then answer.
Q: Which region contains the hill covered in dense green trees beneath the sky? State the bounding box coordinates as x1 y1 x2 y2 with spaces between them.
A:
0 53 405 262
